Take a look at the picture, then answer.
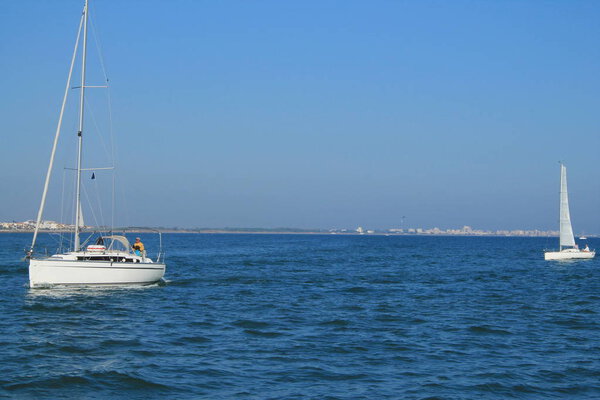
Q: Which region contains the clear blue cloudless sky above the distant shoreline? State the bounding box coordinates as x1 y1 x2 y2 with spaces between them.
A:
0 0 600 232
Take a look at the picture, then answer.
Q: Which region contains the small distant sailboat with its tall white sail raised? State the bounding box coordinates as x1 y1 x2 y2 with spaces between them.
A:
544 163 596 260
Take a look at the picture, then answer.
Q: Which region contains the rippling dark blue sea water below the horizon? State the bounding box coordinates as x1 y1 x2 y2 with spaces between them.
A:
0 234 600 399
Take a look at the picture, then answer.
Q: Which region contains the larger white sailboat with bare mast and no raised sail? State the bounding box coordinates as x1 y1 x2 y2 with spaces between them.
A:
27 0 166 288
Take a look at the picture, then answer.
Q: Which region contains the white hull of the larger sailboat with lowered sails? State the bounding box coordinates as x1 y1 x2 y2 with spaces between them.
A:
29 259 165 288
